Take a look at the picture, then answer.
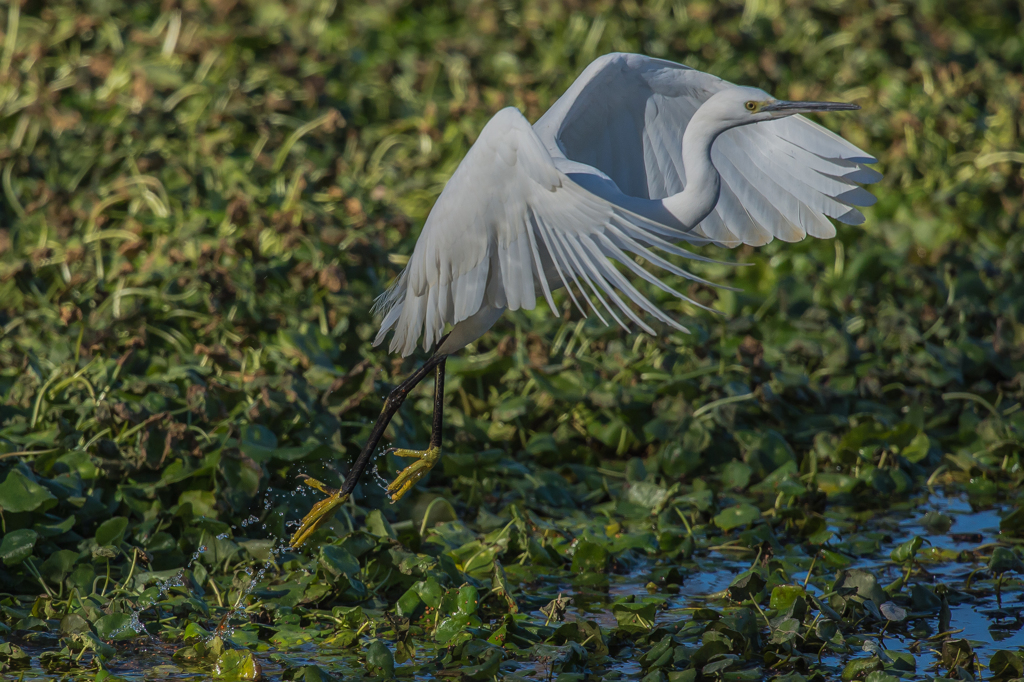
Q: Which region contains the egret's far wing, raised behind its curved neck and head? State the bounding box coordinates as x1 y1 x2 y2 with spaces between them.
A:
535 54 882 246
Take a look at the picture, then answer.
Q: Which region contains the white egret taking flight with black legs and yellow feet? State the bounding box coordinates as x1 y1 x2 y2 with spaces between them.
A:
292 54 882 546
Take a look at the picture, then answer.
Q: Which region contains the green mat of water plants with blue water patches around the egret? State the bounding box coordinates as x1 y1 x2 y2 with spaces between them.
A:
0 0 1024 682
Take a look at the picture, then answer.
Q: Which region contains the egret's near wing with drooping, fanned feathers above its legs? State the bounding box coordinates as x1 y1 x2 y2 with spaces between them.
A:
375 108 706 355
